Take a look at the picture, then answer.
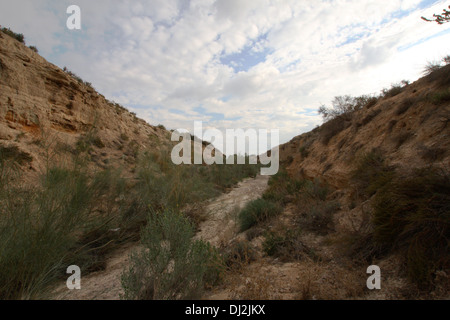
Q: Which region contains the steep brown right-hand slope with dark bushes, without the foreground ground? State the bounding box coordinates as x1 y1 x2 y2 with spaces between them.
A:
270 64 450 298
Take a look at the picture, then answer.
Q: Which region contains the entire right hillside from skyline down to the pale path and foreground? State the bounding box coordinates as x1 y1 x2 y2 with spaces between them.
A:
202 64 450 300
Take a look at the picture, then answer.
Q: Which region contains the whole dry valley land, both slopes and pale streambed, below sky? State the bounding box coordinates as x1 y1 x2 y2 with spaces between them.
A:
0 26 450 299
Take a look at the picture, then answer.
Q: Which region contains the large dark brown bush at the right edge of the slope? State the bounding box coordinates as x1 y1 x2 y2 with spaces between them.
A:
373 168 450 287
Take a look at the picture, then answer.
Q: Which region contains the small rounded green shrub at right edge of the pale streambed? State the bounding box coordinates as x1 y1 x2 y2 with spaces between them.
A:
238 199 282 232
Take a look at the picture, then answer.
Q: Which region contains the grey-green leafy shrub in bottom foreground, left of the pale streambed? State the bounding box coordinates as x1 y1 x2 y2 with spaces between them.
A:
122 211 219 300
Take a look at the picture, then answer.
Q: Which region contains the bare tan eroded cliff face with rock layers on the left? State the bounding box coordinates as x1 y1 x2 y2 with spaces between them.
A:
0 28 169 175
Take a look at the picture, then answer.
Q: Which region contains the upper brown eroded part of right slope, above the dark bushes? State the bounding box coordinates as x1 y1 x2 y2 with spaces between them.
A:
280 65 450 190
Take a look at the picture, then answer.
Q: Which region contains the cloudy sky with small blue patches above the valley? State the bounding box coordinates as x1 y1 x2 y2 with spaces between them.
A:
0 0 450 149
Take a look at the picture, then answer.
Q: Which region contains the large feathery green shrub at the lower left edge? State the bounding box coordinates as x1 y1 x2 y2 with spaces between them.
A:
0 164 91 299
